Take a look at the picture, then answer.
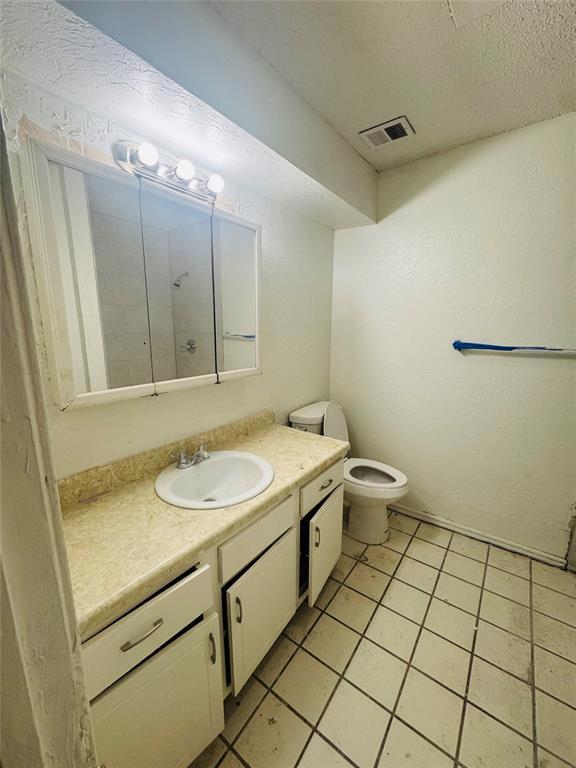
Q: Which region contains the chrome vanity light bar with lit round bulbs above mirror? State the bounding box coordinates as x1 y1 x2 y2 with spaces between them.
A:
113 141 224 205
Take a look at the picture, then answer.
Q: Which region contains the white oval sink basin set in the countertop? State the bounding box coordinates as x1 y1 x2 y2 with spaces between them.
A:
155 451 274 509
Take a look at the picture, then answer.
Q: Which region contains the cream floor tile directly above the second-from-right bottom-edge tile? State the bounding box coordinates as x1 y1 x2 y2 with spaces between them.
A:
468 657 532 738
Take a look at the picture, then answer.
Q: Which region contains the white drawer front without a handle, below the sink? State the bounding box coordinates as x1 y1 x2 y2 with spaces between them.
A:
218 496 297 584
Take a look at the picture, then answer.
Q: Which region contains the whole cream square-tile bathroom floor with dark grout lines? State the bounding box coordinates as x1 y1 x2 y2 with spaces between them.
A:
193 514 576 768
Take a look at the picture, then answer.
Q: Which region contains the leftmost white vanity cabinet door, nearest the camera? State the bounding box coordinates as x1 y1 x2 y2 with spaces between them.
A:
92 614 224 768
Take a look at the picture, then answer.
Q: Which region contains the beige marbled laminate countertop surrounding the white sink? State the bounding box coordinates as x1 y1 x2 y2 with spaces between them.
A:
64 424 348 640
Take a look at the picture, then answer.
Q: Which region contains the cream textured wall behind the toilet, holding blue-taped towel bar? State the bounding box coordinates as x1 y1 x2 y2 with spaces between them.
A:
331 114 576 556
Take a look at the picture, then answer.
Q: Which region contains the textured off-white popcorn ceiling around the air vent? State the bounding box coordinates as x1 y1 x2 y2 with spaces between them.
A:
211 0 576 170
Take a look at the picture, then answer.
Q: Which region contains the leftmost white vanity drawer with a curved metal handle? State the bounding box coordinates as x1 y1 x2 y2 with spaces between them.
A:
82 565 213 699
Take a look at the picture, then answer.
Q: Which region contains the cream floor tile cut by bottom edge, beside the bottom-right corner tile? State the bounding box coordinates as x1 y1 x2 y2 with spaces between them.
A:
460 704 534 768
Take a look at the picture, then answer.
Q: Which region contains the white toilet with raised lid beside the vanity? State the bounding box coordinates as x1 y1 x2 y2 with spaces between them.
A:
289 400 408 544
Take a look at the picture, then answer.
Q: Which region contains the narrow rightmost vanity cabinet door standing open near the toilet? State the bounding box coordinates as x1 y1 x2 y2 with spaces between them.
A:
308 485 344 605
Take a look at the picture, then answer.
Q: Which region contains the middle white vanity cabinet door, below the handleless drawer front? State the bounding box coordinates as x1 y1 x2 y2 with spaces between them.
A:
226 528 298 694
